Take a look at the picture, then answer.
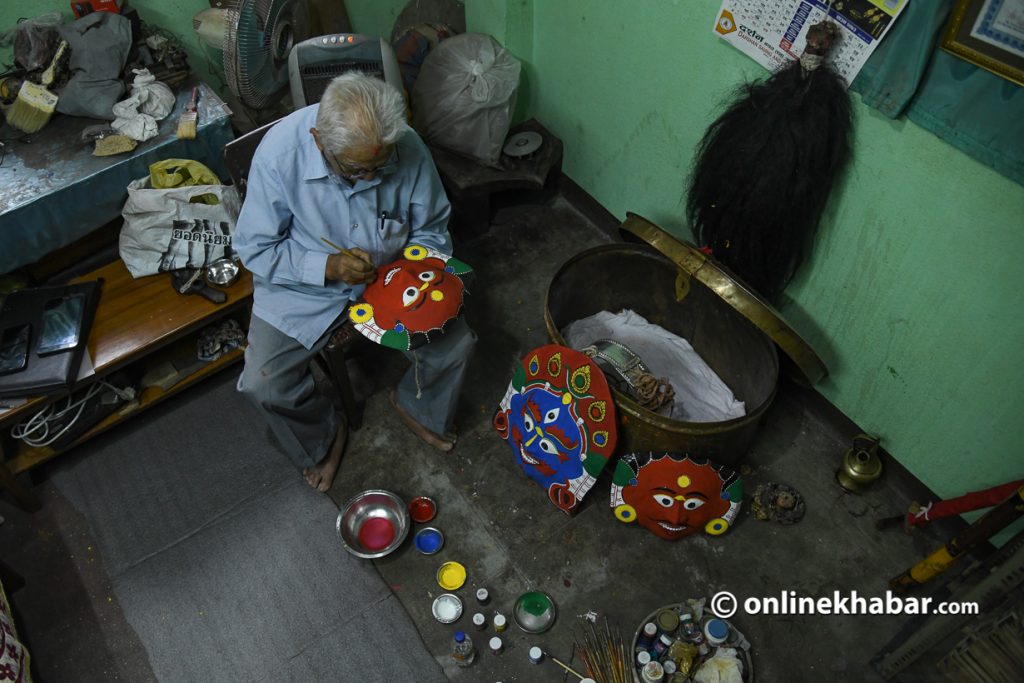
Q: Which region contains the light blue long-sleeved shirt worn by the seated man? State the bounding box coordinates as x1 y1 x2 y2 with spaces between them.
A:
232 104 452 348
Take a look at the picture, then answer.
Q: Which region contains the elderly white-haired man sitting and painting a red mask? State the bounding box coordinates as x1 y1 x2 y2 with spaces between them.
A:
233 74 476 492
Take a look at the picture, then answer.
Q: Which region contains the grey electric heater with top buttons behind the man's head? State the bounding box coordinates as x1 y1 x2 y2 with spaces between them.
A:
288 33 401 109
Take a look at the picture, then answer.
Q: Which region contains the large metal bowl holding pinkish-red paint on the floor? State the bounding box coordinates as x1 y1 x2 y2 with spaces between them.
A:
337 488 409 559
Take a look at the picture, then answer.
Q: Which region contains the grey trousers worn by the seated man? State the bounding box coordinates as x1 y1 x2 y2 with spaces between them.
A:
238 315 476 469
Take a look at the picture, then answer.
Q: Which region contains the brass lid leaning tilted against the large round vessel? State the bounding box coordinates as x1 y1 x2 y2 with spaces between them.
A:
621 212 828 384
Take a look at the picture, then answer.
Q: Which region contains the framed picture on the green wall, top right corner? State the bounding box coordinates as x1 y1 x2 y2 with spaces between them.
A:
942 0 1024 85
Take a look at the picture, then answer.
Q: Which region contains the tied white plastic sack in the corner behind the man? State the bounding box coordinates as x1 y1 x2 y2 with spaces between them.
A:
413 33 521 166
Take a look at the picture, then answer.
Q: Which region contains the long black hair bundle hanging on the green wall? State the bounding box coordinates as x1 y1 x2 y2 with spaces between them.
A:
686 23 851 301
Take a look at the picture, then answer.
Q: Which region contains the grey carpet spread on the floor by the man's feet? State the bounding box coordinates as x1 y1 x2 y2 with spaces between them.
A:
52 373 445 683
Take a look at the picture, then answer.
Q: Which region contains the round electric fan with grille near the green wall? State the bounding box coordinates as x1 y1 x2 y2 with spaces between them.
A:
193 0 310 110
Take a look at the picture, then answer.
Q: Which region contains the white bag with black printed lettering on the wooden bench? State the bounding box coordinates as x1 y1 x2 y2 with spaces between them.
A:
119 176 242 278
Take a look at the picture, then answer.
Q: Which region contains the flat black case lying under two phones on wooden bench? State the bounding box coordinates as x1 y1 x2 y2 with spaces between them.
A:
0 280 102 398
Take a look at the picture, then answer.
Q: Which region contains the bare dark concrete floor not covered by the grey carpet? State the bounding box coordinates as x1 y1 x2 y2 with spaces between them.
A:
0 188 962 683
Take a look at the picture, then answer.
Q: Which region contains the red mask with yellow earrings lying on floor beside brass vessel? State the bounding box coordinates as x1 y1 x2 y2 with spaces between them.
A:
611 453 743 541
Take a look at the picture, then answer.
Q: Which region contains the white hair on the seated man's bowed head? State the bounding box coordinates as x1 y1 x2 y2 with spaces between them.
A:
316 72 406 155
